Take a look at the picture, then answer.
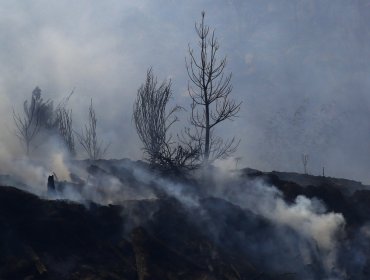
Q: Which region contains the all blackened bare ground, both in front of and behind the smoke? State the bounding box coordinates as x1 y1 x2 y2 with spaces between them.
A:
0 162 370 280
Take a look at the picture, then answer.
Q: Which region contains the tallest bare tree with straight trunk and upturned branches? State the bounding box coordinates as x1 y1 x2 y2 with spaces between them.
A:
186 12 241 164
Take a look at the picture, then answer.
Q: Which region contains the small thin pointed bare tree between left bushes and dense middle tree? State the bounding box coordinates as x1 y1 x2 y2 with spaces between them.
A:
76 99 109 160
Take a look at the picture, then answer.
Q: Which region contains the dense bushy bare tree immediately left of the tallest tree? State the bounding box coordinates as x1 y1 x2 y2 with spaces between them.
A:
133 68 197 169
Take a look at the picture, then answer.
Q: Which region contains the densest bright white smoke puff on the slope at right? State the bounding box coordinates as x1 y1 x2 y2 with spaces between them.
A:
227 177 345 251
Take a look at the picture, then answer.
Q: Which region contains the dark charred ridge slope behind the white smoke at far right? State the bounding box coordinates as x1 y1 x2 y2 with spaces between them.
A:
243 169 370 226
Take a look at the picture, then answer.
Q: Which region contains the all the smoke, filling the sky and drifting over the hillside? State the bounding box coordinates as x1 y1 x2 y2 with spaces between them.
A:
0 0 370 279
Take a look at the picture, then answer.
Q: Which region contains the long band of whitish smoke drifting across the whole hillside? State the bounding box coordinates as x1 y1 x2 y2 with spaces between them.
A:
0 151 345 279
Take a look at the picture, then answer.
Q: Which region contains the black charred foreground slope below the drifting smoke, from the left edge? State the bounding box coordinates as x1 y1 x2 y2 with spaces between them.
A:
0 187 279 279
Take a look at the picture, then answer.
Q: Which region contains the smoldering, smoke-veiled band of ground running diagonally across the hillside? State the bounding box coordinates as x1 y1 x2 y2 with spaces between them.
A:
0 147 356 279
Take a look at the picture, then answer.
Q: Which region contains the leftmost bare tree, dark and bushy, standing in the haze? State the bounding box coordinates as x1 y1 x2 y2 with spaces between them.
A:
13 87 53 155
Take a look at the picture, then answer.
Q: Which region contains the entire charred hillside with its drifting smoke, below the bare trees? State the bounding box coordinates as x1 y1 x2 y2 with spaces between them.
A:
0 160 370 279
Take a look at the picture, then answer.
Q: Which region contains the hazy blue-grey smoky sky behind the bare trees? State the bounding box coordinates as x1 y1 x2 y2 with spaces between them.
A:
0 0 370 183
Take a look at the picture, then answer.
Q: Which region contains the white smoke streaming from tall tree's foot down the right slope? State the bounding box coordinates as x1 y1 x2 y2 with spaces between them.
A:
204 166 346 277
